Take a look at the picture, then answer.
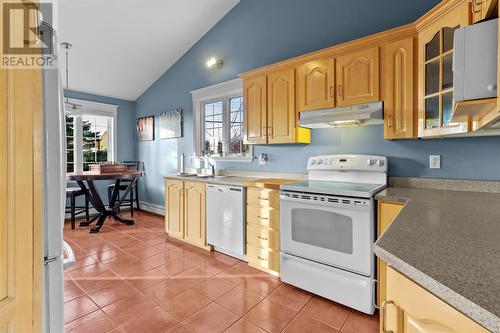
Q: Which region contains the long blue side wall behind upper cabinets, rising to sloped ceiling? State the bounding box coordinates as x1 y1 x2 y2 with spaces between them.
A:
135 0 500 205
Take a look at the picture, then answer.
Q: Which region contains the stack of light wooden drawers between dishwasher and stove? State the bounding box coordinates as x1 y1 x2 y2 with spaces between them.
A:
247 187 280 276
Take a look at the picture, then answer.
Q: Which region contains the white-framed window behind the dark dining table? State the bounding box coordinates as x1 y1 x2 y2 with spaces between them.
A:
66 100 116 172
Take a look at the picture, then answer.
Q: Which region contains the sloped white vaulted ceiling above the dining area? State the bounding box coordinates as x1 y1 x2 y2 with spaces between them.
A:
58 0 239 101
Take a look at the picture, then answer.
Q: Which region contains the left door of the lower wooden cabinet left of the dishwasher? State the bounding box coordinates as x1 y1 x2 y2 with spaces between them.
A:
165 179 184 239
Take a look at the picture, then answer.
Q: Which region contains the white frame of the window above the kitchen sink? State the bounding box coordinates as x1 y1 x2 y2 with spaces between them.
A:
191 78 254 163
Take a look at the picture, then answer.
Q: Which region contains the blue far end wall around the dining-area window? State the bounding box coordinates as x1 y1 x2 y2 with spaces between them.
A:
64 90 137 204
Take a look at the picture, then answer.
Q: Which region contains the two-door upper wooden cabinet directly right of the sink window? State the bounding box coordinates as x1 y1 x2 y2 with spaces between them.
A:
243 68 311 144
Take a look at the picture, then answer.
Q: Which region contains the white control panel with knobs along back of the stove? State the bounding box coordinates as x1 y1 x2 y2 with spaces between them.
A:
307 155 387 172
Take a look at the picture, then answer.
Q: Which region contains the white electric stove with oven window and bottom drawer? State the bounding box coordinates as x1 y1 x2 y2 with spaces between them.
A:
280 155 387 314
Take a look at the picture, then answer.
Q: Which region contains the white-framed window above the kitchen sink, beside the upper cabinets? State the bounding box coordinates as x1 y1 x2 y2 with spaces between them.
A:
192 79 252 162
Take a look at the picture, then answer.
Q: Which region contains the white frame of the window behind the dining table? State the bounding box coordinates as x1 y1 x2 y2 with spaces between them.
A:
64 98 118 172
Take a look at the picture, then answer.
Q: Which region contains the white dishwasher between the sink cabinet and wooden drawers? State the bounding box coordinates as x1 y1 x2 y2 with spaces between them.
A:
206 184 246 260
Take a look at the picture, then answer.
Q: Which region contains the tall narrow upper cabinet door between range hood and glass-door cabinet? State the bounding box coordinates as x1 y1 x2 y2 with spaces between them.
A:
383 37 417 139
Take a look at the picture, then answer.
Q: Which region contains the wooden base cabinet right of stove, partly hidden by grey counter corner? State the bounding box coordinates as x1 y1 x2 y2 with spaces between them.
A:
377 201 403 306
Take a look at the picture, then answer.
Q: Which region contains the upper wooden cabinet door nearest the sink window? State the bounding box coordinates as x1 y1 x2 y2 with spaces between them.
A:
243 76 267 144
